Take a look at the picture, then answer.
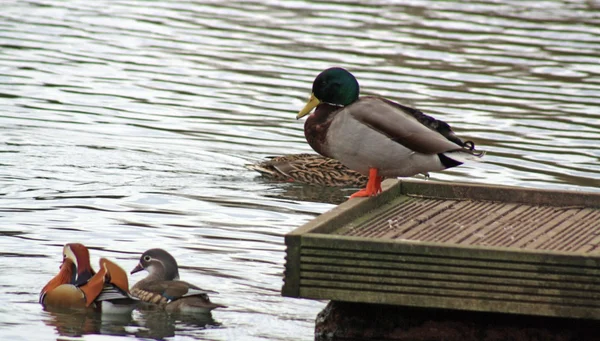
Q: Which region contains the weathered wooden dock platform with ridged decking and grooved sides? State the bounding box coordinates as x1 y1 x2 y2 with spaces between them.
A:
282 180 600 320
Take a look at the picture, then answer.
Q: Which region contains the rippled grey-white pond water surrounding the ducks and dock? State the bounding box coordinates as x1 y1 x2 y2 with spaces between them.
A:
0 0 600 340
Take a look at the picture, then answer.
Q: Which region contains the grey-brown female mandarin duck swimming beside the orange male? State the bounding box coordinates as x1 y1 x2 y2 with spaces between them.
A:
131 249 227 313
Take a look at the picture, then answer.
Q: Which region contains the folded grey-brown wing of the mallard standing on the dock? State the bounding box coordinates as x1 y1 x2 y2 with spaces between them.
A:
340 96 463 154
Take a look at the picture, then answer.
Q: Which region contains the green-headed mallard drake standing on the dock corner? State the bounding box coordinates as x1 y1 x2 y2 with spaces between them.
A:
297 67 484 198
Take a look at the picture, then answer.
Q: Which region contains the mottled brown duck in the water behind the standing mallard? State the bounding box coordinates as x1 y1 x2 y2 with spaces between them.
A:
247 154 368 187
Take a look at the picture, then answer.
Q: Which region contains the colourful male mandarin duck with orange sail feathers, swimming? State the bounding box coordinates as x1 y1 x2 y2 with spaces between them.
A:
39 243 138 313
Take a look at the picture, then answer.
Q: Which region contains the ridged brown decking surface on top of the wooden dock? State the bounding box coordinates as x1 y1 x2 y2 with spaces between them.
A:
340 197 600 252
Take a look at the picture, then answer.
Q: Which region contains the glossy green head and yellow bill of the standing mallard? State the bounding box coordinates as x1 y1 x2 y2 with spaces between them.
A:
296 67 360 119
